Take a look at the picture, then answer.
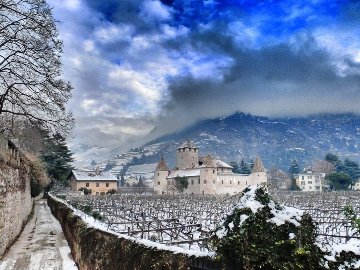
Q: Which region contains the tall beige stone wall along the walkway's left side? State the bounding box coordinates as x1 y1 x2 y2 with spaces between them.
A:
0 138 32 258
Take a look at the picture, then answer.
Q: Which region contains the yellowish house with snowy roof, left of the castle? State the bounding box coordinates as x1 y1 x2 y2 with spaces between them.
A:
68 168 118 195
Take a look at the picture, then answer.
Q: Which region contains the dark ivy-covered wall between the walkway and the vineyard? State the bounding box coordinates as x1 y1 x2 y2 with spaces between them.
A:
48 197 219 270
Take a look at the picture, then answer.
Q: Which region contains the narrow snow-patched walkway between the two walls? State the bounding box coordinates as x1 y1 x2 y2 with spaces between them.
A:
0 200 78 270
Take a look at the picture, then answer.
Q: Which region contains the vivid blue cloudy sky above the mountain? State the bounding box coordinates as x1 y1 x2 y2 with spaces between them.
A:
48 0 360 153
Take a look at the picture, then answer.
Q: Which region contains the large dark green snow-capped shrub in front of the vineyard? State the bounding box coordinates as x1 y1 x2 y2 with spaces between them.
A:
212 186 325 270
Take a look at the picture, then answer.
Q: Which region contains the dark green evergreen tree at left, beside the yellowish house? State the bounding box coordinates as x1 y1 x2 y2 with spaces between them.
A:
41 133 74 182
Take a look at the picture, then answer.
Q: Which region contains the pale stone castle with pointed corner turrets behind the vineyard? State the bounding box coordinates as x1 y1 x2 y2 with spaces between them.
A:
154 141 267 194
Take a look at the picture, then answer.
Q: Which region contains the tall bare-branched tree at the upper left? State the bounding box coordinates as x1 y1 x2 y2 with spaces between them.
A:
0 0 74 134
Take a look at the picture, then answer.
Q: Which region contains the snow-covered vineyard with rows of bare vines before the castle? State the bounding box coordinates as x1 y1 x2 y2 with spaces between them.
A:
62 192 360 251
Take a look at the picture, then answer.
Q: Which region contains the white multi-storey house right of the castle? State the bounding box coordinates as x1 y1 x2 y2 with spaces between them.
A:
296 168 325 192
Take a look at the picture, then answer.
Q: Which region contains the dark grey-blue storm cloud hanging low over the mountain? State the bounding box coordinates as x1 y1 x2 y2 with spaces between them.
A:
155 32 360 136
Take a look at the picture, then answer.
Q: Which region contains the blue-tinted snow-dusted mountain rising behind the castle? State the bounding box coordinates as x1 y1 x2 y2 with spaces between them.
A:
88 113 360 173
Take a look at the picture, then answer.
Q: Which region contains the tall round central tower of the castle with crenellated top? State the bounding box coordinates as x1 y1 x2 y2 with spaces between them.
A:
176 140 199 169
